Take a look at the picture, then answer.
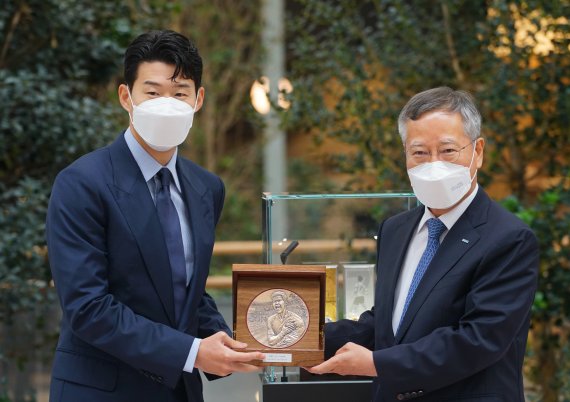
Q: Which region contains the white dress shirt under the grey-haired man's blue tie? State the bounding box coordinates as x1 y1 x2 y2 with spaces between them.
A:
392 184 479 335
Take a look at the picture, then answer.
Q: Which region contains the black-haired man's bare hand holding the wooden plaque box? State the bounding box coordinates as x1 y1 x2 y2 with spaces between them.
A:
194 331 265 376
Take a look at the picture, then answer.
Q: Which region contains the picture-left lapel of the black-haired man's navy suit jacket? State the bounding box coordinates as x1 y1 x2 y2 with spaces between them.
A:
109 135 175 325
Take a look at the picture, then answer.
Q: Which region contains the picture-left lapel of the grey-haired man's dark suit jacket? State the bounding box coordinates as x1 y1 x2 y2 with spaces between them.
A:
377 207 424 346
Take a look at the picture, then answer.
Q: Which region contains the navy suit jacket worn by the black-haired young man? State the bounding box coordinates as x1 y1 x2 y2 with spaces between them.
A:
47 135 231 402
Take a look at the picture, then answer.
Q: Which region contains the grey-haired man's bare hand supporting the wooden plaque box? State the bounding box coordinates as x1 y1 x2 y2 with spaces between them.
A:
307 342 378 377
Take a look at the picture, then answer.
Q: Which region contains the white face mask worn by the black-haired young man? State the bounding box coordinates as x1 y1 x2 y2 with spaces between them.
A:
129 91 198 151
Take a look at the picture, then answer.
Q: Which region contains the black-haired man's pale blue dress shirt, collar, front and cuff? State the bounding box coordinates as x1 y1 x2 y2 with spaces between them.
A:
125 128 201 373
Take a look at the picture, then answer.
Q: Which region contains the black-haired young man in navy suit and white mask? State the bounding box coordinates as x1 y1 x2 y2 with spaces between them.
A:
47 31 263 402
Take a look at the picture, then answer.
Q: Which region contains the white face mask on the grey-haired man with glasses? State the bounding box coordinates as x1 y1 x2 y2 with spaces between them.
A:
408 149 477 209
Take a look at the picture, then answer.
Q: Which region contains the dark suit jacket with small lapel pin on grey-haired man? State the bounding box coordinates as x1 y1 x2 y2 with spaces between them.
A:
325 189 538 402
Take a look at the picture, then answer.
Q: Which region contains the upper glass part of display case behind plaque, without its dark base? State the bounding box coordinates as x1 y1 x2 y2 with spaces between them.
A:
262 193 418 321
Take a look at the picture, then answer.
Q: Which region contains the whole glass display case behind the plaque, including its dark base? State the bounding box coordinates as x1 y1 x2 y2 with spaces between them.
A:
262 192 418 402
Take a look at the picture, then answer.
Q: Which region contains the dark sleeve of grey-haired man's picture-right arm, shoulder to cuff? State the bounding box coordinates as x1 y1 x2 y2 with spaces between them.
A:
374 228 538 392
